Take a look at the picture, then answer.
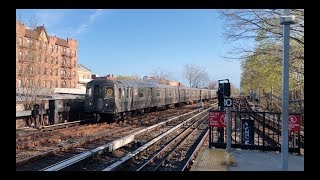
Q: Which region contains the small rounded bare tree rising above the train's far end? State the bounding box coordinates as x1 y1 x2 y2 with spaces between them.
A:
183 64 209 88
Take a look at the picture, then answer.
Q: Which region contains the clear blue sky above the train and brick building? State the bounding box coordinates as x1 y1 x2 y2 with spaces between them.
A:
16 9 241 88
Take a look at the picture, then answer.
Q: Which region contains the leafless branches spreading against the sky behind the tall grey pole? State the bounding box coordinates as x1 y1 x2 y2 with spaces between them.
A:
219 9 304 71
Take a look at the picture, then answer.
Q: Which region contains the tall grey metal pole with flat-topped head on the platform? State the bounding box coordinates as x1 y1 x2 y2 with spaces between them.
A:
280 9 294 171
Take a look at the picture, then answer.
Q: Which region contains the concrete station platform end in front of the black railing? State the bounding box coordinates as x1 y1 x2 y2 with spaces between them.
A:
190 145 304 171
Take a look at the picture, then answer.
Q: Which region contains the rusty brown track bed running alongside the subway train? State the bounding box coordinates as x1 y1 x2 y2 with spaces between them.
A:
16 103 204 165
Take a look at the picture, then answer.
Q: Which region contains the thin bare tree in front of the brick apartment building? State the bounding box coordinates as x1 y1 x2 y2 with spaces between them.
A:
16 18 57 110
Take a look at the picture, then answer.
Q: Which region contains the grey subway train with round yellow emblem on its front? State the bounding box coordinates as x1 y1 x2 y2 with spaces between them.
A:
84 79 216 121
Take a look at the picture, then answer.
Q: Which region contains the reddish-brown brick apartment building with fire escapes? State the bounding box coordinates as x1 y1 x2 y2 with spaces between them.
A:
16 21 78 88
